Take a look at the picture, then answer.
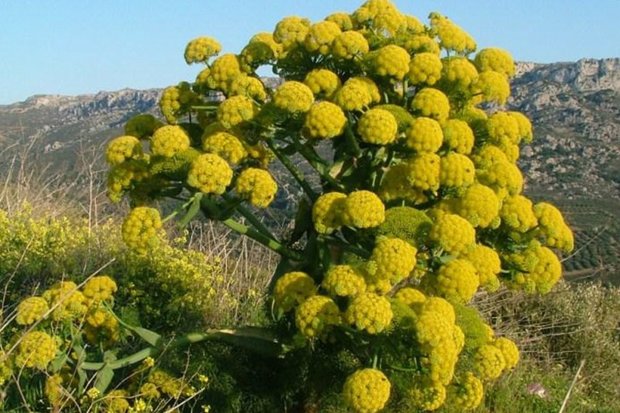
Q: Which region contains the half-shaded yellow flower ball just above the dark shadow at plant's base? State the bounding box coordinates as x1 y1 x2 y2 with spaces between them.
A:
295 295 341 338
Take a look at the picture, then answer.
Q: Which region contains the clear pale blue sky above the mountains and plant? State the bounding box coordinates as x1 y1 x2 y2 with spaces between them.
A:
0 0 620 104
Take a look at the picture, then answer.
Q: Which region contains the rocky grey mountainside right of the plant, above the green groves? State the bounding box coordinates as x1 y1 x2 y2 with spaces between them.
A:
510 59 620 198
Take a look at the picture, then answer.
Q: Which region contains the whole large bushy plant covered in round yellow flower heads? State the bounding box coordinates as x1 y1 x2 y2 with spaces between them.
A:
3 0 573 412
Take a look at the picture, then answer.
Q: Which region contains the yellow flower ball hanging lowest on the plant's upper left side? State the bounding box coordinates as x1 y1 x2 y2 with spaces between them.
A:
121 207 162 254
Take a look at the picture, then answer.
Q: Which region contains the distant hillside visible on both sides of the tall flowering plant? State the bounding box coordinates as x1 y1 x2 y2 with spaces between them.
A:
0 58 620 277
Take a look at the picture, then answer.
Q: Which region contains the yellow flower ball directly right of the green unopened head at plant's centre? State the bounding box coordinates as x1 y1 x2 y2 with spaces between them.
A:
429 213 476 255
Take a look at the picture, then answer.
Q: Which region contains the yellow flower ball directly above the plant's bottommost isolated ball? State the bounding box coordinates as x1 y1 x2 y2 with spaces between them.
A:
344 292 394 334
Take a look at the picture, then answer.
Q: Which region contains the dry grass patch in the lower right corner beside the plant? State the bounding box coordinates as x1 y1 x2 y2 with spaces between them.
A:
476 282 620 401
